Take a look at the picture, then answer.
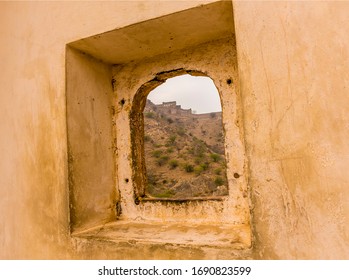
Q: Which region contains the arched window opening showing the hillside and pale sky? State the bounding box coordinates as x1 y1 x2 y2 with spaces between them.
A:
143 74 228 200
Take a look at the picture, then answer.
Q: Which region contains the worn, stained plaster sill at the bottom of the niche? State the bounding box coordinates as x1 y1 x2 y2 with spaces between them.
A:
72 221 251 250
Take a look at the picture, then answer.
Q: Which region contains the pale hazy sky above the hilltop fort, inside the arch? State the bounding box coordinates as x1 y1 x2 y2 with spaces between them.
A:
148 75 222 114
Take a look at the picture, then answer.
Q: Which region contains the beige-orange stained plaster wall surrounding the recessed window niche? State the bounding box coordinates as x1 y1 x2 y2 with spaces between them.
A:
0 1 349 259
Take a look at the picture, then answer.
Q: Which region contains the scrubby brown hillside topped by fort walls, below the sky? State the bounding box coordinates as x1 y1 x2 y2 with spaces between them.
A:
144 100 227 199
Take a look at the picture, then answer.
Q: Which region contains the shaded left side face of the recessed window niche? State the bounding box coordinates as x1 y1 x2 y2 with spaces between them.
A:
66 48 118 231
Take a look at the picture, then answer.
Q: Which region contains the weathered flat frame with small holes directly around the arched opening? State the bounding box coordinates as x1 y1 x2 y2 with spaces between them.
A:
113 38 249 230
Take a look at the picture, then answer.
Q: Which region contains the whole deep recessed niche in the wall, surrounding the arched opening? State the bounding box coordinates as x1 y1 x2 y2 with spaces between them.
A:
66 1 251 250
